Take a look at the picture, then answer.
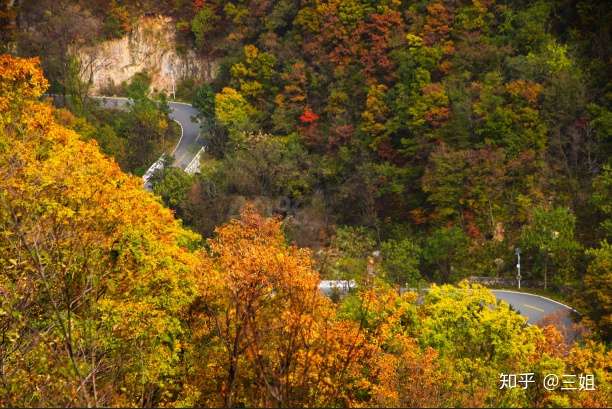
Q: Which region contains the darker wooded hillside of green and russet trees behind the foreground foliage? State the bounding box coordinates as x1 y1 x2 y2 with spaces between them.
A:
2 0 612 340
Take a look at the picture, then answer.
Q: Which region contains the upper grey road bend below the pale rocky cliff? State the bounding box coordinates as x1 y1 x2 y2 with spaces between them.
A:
93 96 203 170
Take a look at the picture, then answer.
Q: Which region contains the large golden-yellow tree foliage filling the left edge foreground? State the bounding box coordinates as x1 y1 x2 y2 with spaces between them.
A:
0 55 203 407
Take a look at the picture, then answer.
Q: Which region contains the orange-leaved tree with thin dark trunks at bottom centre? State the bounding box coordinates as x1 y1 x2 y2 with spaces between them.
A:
184 207 370 407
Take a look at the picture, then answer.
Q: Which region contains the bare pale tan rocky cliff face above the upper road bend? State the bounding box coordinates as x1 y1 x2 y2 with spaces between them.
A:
77 17 218 94
